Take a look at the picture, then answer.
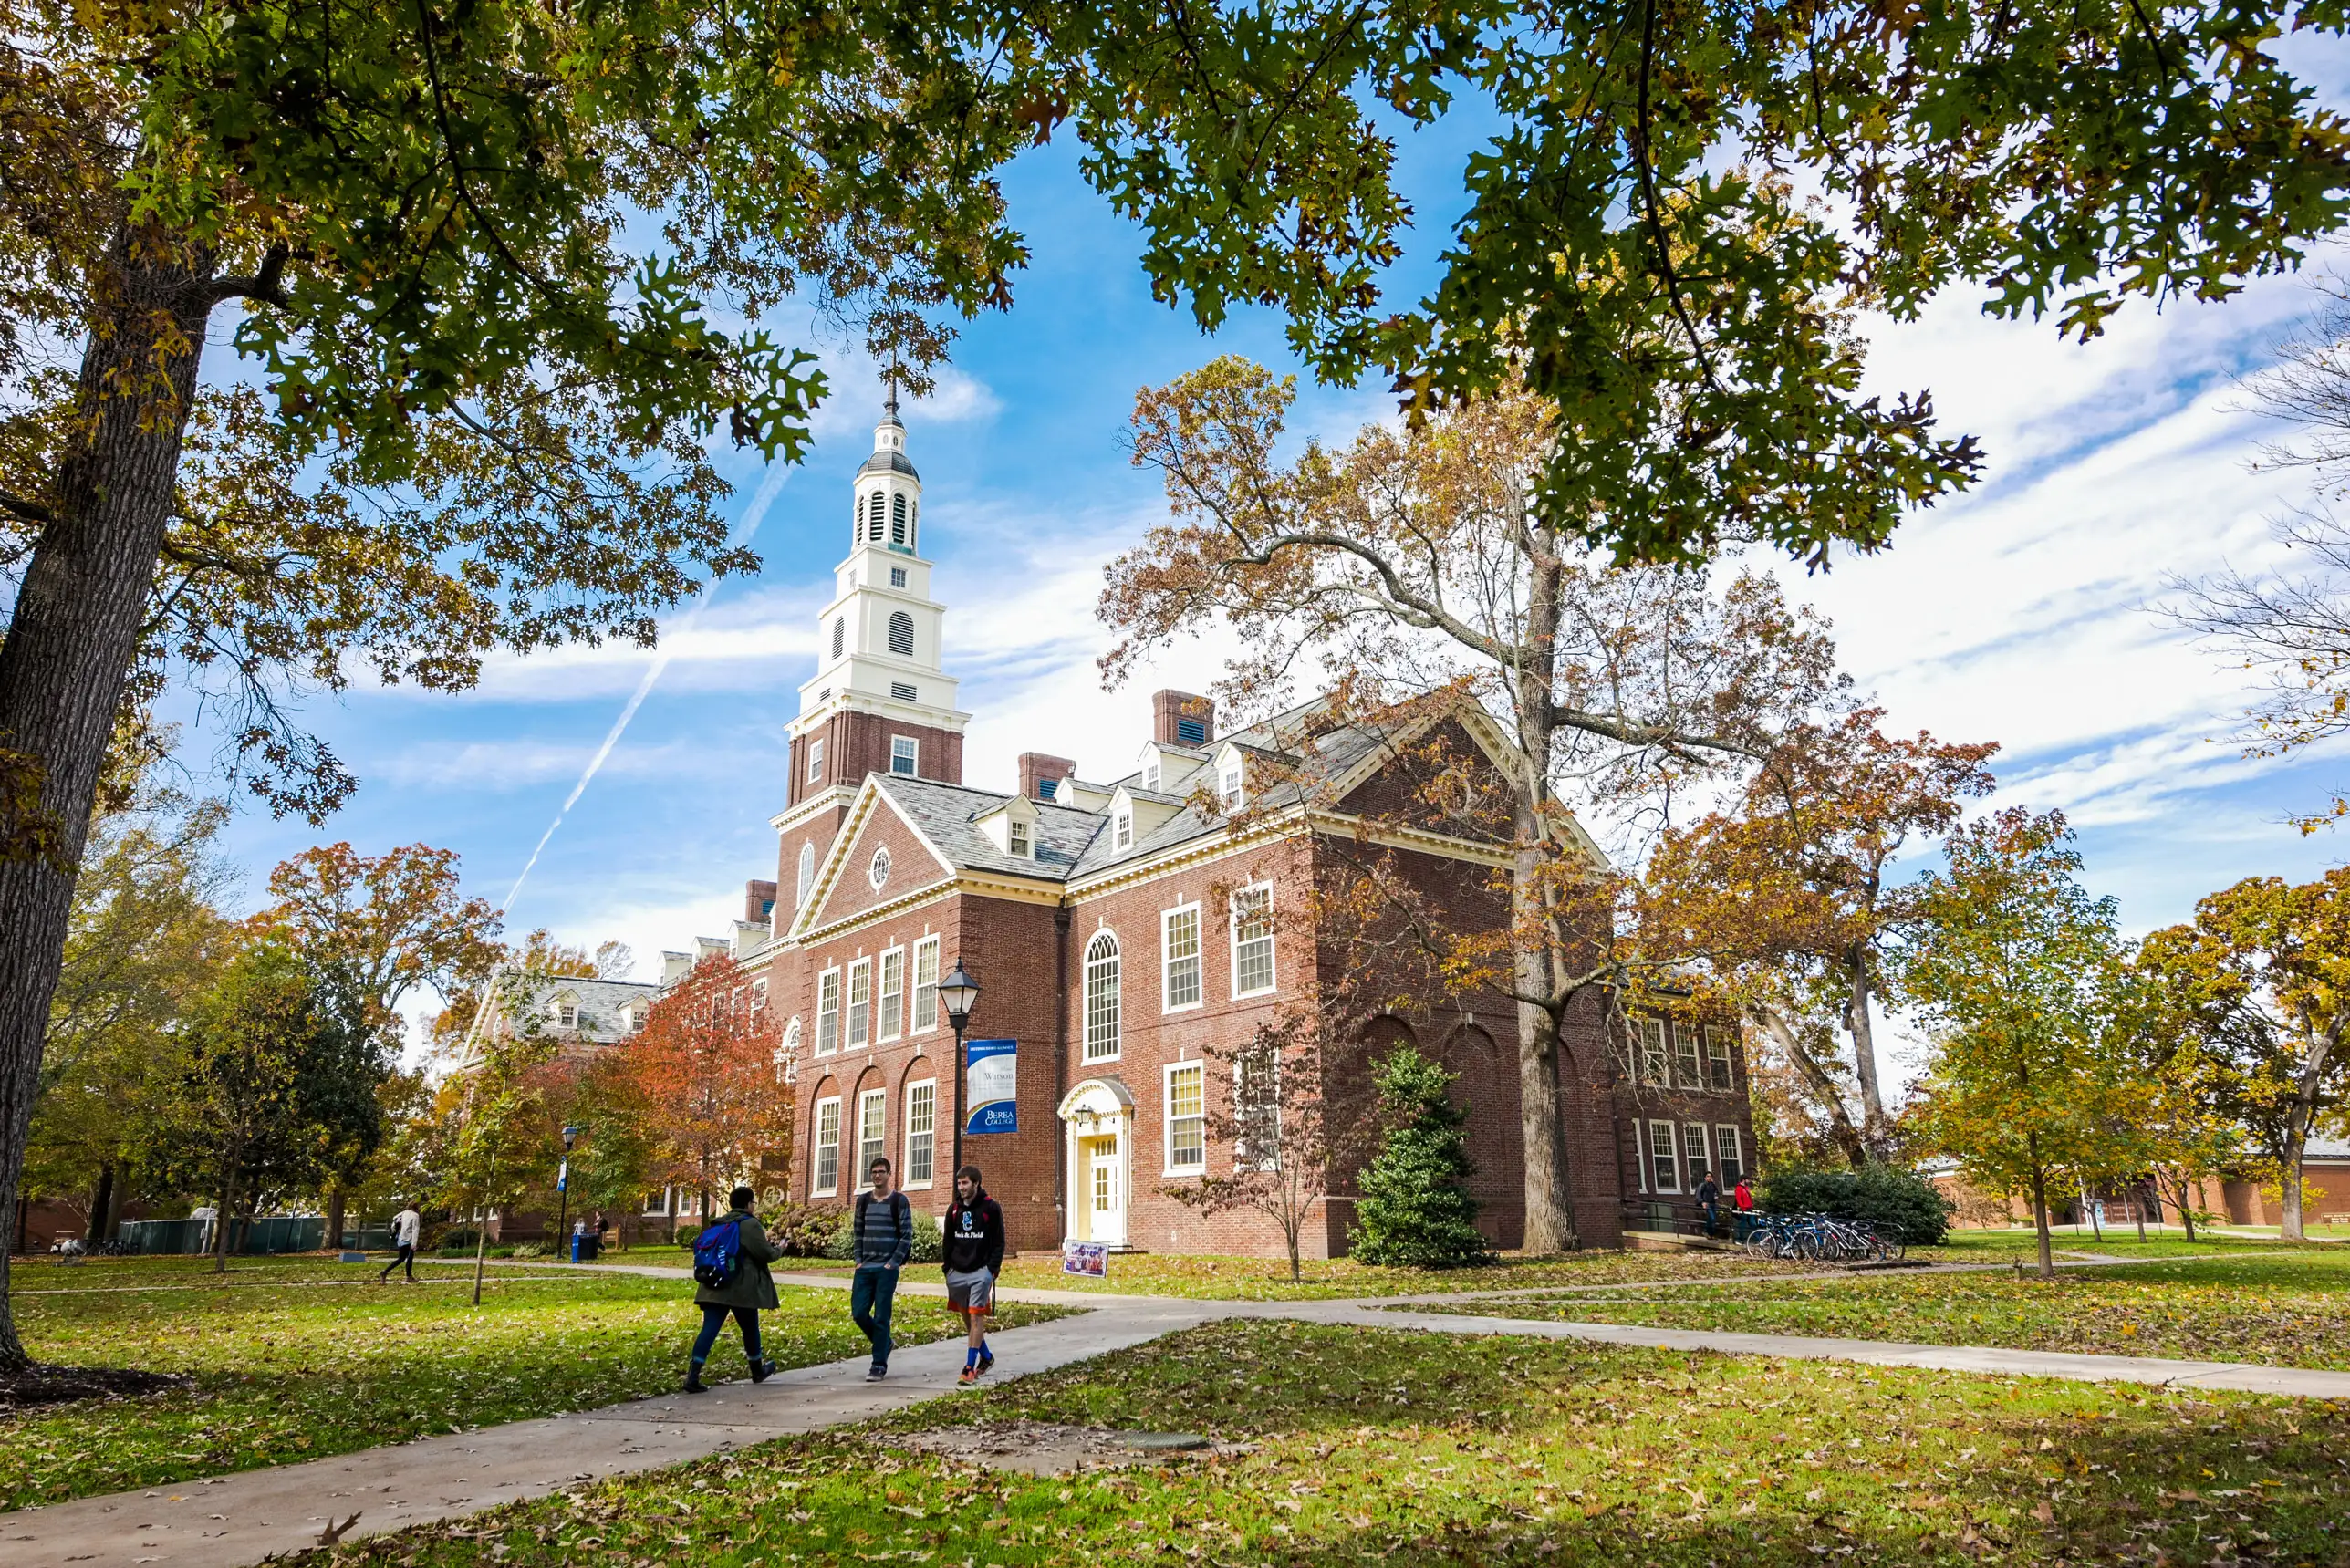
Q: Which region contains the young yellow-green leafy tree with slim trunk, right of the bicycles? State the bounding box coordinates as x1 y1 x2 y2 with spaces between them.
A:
1897 806 2143 1279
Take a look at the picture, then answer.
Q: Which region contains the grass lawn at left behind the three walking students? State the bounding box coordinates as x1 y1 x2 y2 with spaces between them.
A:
0 1260 1057 1510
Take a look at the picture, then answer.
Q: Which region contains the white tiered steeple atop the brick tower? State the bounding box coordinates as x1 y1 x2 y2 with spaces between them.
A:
792 394 971 752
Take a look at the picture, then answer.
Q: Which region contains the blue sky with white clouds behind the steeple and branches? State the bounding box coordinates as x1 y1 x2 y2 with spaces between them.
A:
173 107 2350 1053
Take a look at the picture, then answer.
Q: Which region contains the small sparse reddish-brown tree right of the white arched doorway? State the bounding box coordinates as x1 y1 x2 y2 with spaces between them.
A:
1161 1013 1339 1282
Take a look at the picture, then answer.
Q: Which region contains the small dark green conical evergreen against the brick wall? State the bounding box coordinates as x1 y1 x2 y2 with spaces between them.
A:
1349 1046 1492 1270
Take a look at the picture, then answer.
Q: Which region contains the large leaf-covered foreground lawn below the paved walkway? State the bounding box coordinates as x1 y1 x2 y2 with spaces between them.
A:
284 1321 2350 1568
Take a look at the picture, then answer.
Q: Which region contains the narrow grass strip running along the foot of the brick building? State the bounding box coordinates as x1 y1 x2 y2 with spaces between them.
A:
982 1253 1803 1300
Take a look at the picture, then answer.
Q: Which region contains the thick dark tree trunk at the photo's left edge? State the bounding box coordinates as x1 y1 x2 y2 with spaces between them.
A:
0 235 212 1371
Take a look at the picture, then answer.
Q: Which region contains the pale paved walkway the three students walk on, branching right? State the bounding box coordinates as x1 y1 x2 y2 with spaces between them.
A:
18 1265 2350 1568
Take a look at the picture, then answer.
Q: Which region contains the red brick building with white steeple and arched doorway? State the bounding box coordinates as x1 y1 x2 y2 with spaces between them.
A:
674 407 1753 1255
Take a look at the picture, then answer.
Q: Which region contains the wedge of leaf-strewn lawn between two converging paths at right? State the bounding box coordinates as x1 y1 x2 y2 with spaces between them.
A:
1419 1243 2350 1371
